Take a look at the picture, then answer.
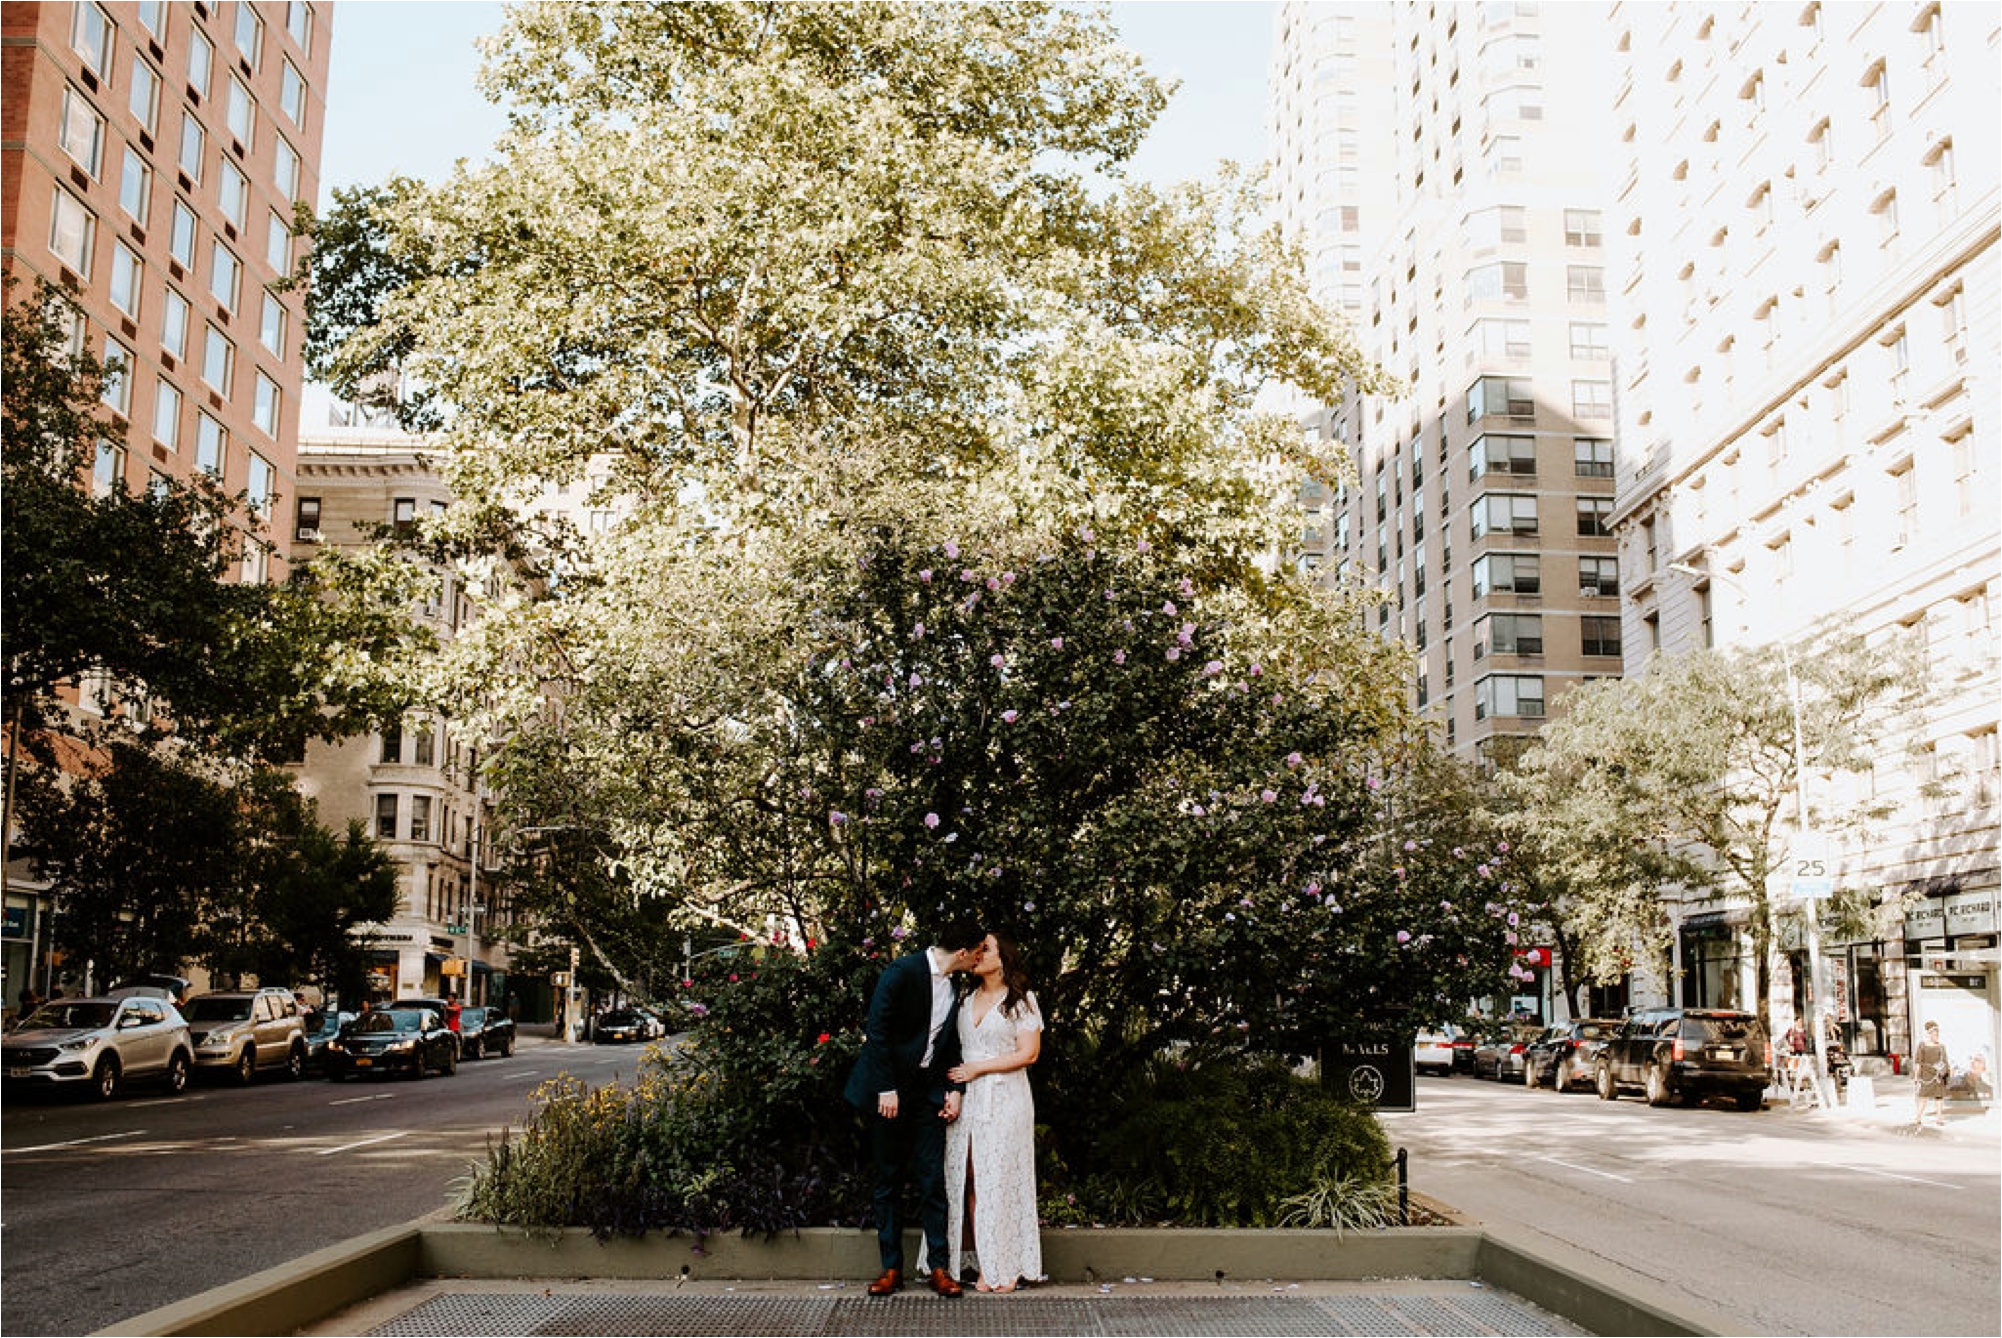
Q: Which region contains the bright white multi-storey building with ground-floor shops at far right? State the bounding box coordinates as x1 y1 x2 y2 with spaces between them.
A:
1606 0 2002 1060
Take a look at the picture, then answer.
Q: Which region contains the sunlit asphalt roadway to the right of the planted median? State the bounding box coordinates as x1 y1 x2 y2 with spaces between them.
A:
1385 1076 2002 1334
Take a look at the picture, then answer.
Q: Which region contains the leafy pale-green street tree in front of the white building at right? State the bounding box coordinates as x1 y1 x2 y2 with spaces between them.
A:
1508 631 1918 1012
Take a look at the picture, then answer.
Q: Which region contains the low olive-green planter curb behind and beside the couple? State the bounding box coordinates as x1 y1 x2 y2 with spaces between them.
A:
98 1216 1752 1336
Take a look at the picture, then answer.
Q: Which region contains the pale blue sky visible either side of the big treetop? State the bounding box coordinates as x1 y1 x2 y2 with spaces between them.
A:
320 0 1275 206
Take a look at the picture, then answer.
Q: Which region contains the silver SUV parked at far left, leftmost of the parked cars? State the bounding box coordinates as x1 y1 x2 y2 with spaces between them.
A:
0 995 194 1100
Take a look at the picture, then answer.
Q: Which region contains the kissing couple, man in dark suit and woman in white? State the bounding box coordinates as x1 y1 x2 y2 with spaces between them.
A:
845 919 1043 1296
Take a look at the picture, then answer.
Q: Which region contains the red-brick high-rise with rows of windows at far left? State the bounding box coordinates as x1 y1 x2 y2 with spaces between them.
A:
0 0 332 581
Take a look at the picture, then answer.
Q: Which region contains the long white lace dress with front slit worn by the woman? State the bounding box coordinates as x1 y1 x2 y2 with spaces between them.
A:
945 993 1043 1286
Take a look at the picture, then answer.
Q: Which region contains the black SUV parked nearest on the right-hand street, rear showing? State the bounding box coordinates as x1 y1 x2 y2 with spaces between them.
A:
1592 1008 1772 1110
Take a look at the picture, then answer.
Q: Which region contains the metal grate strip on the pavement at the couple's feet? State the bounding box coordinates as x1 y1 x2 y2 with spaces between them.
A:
370 1290 1576 1338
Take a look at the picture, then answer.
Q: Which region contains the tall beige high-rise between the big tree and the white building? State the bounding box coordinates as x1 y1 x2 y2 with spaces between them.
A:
1269 0 1624 761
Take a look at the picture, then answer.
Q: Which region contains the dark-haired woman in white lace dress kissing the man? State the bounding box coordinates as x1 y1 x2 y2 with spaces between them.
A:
945 933 1043 1292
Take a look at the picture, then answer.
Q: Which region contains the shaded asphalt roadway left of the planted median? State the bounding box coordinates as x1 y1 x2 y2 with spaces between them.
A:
0 1044 639 1334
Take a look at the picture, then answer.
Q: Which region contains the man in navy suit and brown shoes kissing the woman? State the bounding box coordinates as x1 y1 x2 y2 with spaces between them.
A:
845 921 987 1296
